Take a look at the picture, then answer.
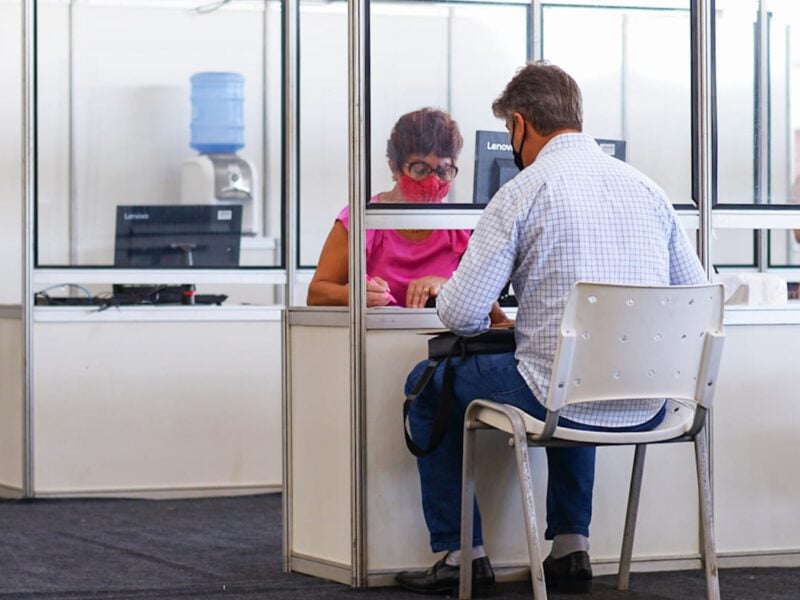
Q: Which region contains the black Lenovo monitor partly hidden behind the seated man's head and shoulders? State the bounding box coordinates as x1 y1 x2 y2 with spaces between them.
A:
472 130 625 204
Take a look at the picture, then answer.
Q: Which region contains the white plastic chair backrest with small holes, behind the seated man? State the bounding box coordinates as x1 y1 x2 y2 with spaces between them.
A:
547 282 724 410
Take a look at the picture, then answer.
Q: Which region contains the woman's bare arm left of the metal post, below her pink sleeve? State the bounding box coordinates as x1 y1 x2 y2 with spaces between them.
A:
306 221 349 306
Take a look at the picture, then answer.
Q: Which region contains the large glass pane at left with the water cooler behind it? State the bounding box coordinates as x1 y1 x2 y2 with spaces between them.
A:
36 0 282 268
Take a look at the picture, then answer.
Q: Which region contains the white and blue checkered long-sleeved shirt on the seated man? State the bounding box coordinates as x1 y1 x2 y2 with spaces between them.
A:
437 133 707 427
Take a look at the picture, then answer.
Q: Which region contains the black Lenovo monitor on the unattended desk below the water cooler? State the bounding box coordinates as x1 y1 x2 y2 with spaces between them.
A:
114 204 242 269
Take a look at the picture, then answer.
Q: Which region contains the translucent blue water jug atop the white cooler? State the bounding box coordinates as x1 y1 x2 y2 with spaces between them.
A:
190 72 244 154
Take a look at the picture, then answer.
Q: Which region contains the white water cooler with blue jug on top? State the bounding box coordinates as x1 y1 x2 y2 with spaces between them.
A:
181 72 261 236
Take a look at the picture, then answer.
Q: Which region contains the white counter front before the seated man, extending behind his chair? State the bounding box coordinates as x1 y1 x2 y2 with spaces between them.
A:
285 306 800 585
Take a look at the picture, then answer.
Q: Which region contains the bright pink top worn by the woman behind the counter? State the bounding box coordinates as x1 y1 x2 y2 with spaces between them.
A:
336 202 470 306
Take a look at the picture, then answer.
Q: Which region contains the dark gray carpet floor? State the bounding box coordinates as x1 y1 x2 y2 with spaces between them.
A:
0 494 800 600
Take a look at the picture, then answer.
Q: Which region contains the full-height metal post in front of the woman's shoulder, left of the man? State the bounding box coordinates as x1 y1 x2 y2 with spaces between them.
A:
347 0 369 587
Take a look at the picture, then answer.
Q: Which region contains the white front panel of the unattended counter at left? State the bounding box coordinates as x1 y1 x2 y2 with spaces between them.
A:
9 306 281 497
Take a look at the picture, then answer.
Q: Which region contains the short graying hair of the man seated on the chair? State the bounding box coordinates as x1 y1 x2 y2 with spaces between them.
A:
492 61 583 135
